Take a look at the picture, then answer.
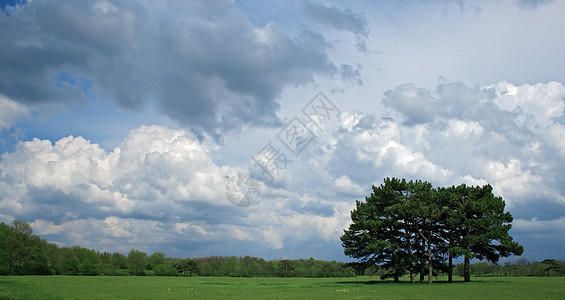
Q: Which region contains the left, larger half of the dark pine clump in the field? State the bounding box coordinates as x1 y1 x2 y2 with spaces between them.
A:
341 178 442 282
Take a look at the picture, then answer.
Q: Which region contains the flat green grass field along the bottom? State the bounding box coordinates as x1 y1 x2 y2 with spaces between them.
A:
0 276 565 300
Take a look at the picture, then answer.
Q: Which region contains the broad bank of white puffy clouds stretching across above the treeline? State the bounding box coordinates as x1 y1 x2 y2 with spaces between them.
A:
0 82 565 259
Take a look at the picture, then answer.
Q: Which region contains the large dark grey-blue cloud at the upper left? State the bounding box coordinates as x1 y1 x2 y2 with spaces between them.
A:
0 1 342 132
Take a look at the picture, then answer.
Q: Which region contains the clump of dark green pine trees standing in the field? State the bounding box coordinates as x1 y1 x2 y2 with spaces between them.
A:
341 178 524 283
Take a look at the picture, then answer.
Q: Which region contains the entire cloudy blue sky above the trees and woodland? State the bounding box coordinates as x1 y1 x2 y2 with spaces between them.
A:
0 0 565 261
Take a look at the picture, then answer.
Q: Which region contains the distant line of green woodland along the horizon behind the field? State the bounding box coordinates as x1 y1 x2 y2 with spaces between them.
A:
0 220 565 277
